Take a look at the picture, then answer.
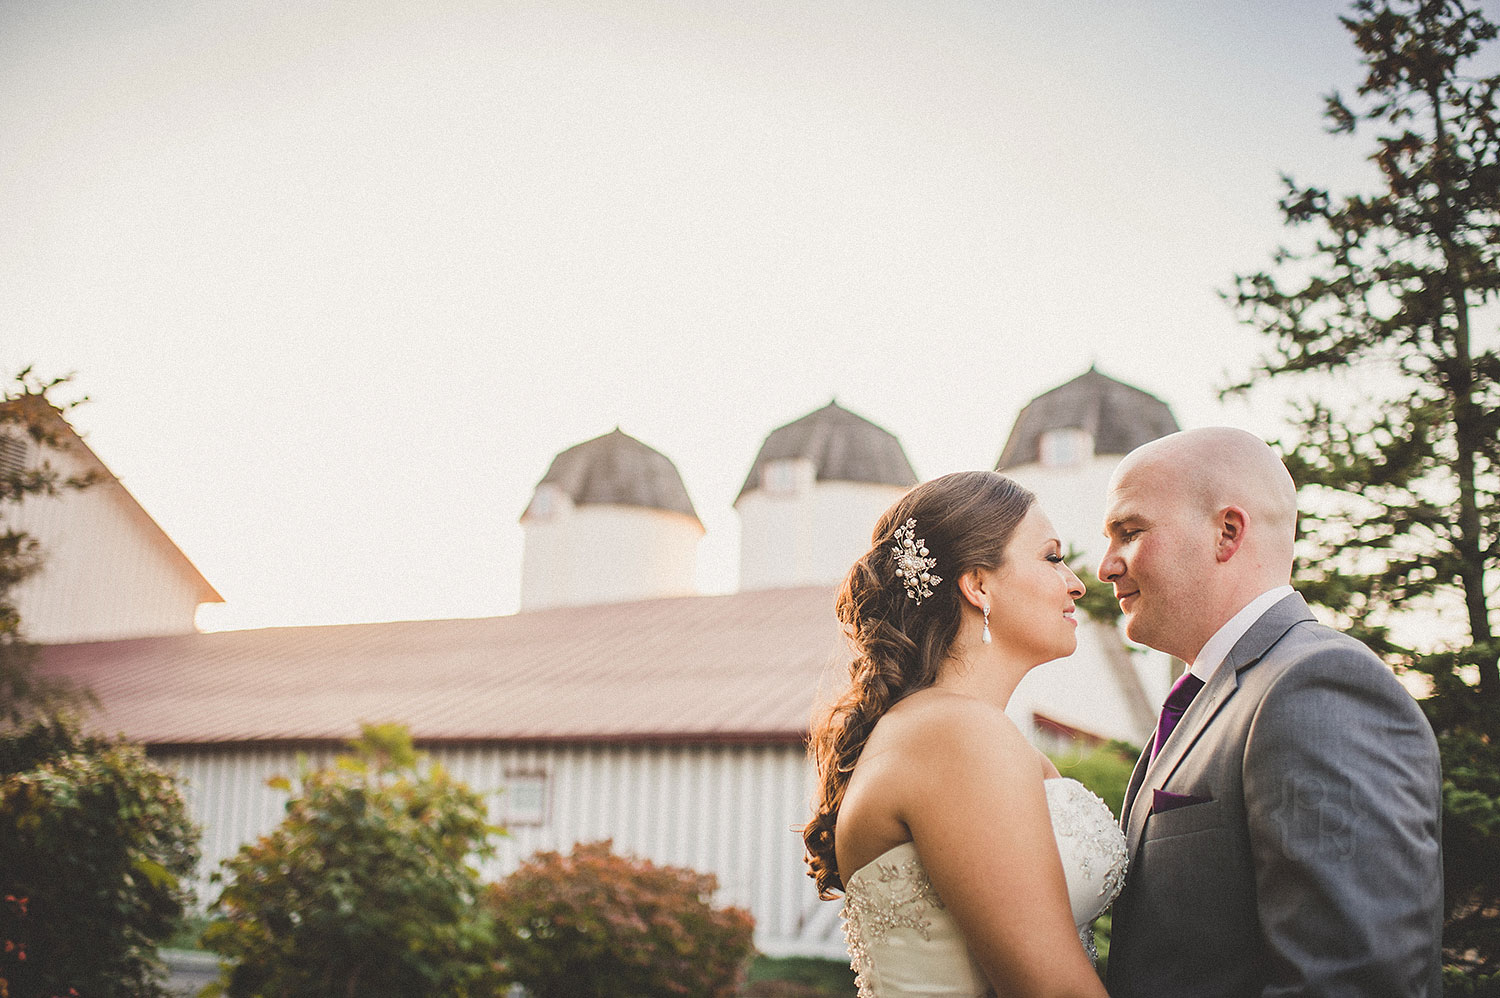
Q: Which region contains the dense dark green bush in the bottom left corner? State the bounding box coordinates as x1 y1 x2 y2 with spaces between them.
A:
0 719 198 998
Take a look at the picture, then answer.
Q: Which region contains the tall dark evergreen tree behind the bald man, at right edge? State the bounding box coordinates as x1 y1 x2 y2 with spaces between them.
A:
1226 0 1500 974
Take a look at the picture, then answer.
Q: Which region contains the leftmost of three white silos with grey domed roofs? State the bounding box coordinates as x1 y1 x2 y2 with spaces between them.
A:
521 428 704 611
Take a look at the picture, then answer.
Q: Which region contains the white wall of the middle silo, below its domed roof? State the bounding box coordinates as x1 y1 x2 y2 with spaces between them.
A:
735 482 908 590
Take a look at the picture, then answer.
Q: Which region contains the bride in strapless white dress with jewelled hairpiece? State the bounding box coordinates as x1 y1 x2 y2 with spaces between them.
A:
803 471 1125 998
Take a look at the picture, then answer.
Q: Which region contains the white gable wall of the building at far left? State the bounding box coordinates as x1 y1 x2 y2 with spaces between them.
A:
6 441 203 644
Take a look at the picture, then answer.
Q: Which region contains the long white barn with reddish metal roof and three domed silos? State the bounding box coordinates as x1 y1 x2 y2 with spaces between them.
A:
20 369 1176 956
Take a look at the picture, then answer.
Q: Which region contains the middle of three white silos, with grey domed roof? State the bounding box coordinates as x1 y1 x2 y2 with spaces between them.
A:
735 402 917 590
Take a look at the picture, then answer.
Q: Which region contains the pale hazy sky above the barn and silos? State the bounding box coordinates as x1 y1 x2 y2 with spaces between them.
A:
0 0 1452 629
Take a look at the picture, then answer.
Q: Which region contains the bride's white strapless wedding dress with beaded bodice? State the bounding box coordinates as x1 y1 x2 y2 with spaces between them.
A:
843 779 1125 998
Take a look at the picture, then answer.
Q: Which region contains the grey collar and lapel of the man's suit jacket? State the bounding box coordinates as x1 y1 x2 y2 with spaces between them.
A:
1124 593 1314 855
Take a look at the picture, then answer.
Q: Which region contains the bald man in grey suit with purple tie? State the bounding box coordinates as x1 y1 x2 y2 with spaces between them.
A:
1100 428 1443 998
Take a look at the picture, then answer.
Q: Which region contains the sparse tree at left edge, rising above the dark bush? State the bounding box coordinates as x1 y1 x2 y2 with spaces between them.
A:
0 368 93 726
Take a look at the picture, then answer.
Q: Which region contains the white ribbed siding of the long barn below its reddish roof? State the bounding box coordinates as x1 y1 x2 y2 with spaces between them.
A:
153 744 845 957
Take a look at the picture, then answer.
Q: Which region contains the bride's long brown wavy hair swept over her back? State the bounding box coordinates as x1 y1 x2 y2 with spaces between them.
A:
803 471 1037 900
